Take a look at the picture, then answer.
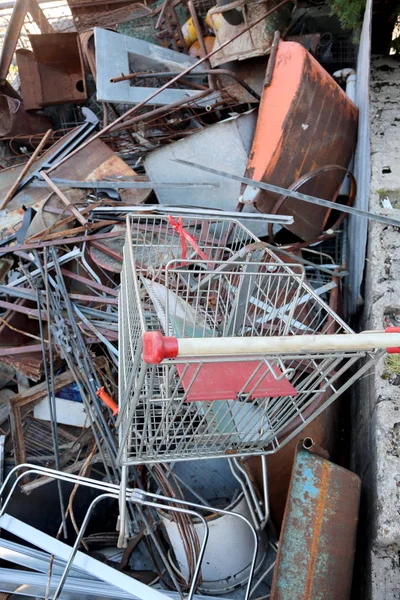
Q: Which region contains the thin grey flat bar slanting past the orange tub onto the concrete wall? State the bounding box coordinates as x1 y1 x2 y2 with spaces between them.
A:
172 158 400 227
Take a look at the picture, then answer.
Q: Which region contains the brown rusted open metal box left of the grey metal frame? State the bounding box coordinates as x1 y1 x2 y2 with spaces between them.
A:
16 32 88 110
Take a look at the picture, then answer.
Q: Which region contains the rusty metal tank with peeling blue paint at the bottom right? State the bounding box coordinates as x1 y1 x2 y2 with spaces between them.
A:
271 438 361 600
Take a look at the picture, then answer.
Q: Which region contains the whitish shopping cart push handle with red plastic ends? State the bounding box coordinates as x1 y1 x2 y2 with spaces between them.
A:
143 327 400 365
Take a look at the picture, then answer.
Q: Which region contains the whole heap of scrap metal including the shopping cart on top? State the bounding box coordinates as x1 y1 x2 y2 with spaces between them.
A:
0 0 400 600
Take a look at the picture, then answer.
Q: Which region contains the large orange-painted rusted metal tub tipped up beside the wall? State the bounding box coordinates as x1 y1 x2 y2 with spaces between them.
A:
243 42 358 240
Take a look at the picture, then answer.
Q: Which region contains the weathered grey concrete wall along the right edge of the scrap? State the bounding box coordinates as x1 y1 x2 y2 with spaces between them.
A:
352 57 400 600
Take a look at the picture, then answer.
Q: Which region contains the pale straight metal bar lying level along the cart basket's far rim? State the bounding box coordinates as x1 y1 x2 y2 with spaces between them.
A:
93 204 294 225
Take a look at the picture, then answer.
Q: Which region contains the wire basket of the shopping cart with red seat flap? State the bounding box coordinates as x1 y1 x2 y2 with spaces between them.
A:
120 218 374 464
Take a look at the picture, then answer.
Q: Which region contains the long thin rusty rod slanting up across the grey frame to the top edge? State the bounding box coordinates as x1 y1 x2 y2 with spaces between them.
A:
48 0 289 173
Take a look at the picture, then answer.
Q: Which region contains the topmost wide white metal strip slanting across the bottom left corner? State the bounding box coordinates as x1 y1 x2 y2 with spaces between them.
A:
0 512 170 600
